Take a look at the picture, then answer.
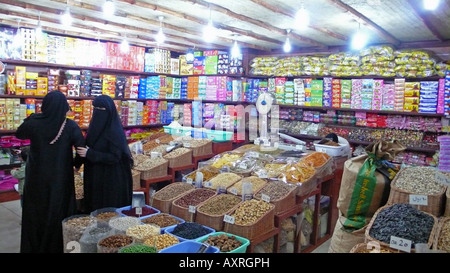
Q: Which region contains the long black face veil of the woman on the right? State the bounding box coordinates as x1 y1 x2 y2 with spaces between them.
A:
86 95 131 158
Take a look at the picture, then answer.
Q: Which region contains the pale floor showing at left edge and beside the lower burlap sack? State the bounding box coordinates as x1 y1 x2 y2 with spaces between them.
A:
0 200 331 253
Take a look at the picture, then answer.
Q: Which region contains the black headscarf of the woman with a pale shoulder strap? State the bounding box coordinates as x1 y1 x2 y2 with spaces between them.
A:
29 91 70 144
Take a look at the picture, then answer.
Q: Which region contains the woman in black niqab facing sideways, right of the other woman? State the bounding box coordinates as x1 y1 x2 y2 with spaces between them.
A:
77 95 133 212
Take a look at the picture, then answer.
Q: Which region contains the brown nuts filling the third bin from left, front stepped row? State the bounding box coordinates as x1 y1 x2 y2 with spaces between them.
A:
197 194 242 216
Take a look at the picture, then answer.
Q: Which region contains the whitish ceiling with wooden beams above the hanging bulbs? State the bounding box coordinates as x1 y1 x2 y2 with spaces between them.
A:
0 0 450 60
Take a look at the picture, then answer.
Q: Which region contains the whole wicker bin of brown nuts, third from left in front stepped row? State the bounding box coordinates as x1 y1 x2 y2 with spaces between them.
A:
195 194 242 231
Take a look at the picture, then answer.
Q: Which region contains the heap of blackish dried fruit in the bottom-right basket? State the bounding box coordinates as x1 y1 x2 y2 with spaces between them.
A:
369 204 434 245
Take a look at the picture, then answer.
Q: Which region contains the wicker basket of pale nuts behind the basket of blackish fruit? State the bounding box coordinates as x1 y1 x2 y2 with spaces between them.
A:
387 167 447 217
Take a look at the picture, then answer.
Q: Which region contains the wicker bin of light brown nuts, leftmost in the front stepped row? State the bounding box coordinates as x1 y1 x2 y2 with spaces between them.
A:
152 182 195 213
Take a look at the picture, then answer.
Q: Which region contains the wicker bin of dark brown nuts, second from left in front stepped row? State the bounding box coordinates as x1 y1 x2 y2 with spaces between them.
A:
170 188 216 222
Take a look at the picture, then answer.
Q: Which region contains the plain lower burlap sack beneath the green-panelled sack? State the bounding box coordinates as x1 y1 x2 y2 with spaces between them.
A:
328 212 366 253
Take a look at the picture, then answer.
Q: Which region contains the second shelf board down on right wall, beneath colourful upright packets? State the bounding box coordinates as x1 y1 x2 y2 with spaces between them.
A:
277 104 444 117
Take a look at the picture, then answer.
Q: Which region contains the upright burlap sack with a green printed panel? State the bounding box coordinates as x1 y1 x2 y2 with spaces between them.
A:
337 141 405 230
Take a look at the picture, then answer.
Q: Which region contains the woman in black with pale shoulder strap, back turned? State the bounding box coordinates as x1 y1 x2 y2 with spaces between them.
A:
16 91 85 253
